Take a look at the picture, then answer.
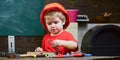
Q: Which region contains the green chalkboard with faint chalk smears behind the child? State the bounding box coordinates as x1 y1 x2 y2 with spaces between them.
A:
0 0 45 36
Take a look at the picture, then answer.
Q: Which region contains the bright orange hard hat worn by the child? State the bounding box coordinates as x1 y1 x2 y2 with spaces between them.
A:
40 3 70 30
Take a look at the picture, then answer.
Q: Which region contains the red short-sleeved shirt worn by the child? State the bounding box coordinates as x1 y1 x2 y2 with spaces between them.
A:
42 31 78 54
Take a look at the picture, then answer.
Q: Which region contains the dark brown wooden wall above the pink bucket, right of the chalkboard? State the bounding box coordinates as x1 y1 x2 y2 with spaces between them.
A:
45 0 120 23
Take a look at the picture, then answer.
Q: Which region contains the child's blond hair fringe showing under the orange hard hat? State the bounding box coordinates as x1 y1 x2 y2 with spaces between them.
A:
44 11 66 22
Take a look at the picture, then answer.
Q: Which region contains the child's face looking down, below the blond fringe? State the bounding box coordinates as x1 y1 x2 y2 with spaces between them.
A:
46 17 64 35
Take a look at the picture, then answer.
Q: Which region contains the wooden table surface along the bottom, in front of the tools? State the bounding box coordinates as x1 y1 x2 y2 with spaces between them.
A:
0 56 120 60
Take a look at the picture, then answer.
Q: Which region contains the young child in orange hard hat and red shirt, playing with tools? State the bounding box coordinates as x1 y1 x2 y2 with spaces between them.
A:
35 3 78 55
